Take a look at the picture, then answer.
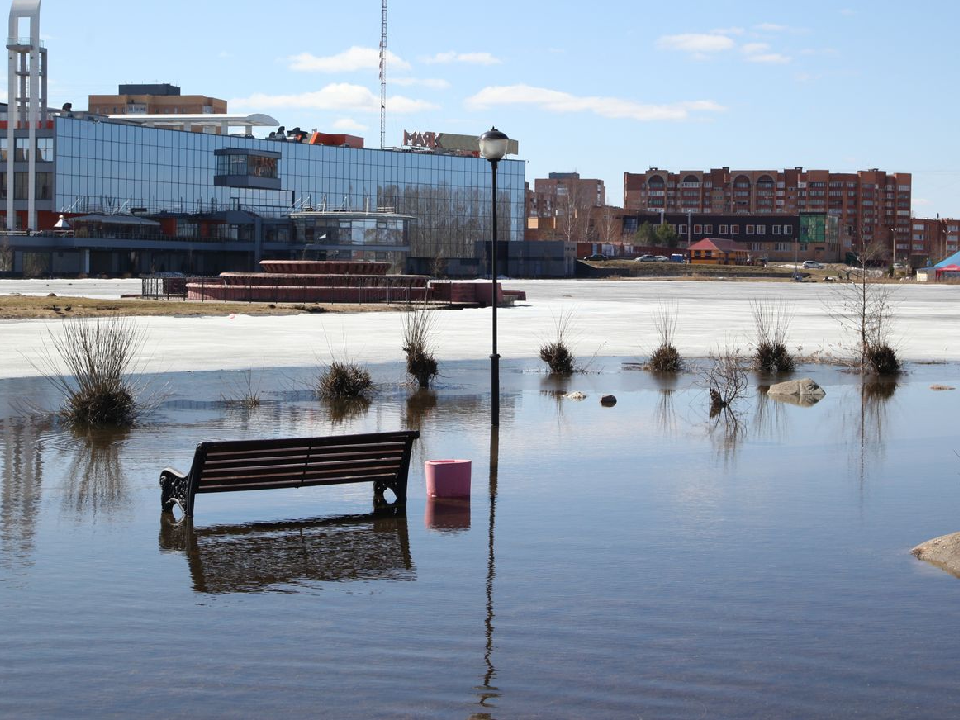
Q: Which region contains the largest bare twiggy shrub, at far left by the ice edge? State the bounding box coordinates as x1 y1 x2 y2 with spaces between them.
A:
37 317 146 428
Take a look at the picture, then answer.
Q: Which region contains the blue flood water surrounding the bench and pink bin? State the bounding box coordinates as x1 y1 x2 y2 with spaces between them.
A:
0 358 960 718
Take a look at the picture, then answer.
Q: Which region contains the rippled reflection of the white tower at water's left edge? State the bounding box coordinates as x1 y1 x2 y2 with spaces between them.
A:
0 418 53 567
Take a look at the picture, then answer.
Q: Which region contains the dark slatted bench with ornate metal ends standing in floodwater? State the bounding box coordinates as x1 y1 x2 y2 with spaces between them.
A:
160 430 420 517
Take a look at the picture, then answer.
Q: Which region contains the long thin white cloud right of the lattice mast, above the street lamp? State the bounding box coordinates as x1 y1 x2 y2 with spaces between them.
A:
465 85 725 121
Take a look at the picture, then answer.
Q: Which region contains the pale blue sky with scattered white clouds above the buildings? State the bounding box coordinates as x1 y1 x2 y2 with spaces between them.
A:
8 0 960 218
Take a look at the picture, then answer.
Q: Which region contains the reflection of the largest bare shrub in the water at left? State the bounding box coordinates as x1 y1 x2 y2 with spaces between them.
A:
64 431 127 515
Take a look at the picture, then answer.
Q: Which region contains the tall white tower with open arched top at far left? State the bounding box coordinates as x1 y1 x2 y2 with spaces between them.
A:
7 0 47 230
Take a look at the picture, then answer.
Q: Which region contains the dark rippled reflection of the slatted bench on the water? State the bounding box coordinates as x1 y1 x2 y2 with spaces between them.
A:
159 513 416 594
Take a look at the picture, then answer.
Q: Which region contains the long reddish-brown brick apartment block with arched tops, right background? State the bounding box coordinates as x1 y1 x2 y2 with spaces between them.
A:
623 167 912 259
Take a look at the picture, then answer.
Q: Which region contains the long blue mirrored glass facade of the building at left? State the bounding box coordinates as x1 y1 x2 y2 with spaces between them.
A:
37 117 525 270
